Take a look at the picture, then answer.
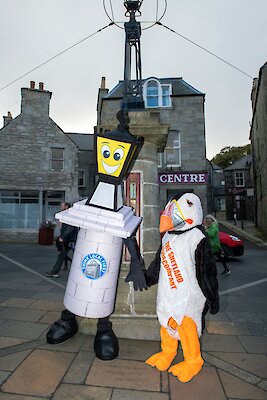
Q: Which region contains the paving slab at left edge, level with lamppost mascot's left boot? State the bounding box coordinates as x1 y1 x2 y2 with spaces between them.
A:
0 321 49 339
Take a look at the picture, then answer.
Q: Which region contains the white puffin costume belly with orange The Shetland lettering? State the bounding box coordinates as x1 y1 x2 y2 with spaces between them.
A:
157 228 206 339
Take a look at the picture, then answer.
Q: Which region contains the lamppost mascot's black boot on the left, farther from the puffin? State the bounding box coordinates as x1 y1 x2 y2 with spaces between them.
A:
46 310 78 344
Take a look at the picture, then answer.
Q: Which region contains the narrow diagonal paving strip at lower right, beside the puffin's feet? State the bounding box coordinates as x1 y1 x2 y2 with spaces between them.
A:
202 352 266 391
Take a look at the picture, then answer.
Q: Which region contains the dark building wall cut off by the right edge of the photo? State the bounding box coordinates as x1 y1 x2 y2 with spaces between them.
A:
250 63 267 235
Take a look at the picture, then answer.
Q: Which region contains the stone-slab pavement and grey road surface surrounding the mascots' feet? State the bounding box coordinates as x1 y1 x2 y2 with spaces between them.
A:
0 222 267 400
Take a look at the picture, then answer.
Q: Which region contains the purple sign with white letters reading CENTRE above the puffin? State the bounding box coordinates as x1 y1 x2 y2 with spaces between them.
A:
159 172 208 185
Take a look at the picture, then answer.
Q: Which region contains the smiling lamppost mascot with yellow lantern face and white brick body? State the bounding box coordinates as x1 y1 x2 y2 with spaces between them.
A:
46 109 147 360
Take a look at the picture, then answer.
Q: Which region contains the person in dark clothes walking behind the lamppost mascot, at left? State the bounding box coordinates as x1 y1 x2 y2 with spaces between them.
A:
45 202 78 278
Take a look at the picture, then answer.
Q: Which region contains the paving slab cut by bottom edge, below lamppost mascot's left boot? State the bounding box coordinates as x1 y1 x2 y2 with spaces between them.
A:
53 383 112 400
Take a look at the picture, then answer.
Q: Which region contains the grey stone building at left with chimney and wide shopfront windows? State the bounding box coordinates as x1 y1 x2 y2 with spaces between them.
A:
0 81 79 238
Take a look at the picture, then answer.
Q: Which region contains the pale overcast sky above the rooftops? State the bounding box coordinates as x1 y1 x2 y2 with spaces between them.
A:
0 0 267 159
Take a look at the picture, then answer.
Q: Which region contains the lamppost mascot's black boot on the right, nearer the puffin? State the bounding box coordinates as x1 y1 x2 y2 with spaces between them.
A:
94 317 119 361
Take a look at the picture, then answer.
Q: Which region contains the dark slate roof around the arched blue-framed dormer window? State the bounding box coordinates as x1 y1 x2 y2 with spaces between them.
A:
104 77 204 99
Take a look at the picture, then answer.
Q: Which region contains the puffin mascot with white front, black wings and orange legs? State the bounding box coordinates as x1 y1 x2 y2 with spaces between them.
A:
146 193 219 382
